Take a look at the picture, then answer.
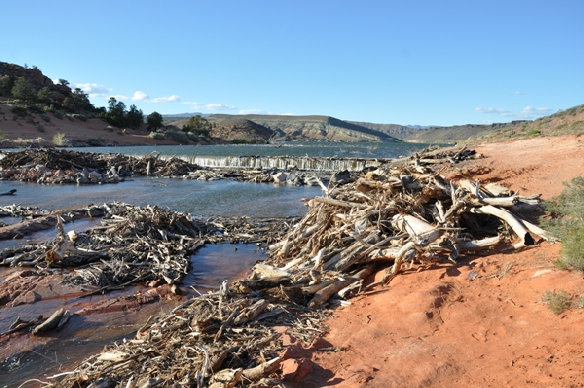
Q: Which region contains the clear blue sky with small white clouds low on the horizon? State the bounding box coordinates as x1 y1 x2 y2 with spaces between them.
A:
0 0 584 125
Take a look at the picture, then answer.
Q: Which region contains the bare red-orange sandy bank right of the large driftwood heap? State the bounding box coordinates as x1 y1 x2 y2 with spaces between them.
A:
284 136 584 387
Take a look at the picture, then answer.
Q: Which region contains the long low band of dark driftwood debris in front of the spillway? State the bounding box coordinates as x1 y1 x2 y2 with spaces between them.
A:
0 148 323 186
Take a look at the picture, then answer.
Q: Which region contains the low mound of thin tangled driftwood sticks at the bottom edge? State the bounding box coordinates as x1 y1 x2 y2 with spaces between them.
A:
51 282 323 388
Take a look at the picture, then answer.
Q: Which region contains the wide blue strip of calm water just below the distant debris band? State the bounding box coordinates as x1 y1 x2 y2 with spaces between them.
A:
0 178 321 217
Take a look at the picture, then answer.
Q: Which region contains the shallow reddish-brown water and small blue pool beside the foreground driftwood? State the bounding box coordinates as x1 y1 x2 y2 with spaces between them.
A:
0 244 265 387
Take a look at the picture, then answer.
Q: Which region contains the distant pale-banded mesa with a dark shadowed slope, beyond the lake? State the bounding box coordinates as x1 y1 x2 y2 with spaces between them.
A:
208 114 396 141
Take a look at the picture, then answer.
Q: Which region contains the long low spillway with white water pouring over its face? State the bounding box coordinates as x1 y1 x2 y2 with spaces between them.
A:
155 155 386 171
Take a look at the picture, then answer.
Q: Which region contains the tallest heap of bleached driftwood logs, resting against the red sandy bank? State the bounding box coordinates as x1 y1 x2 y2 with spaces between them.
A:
249 148 548 307
